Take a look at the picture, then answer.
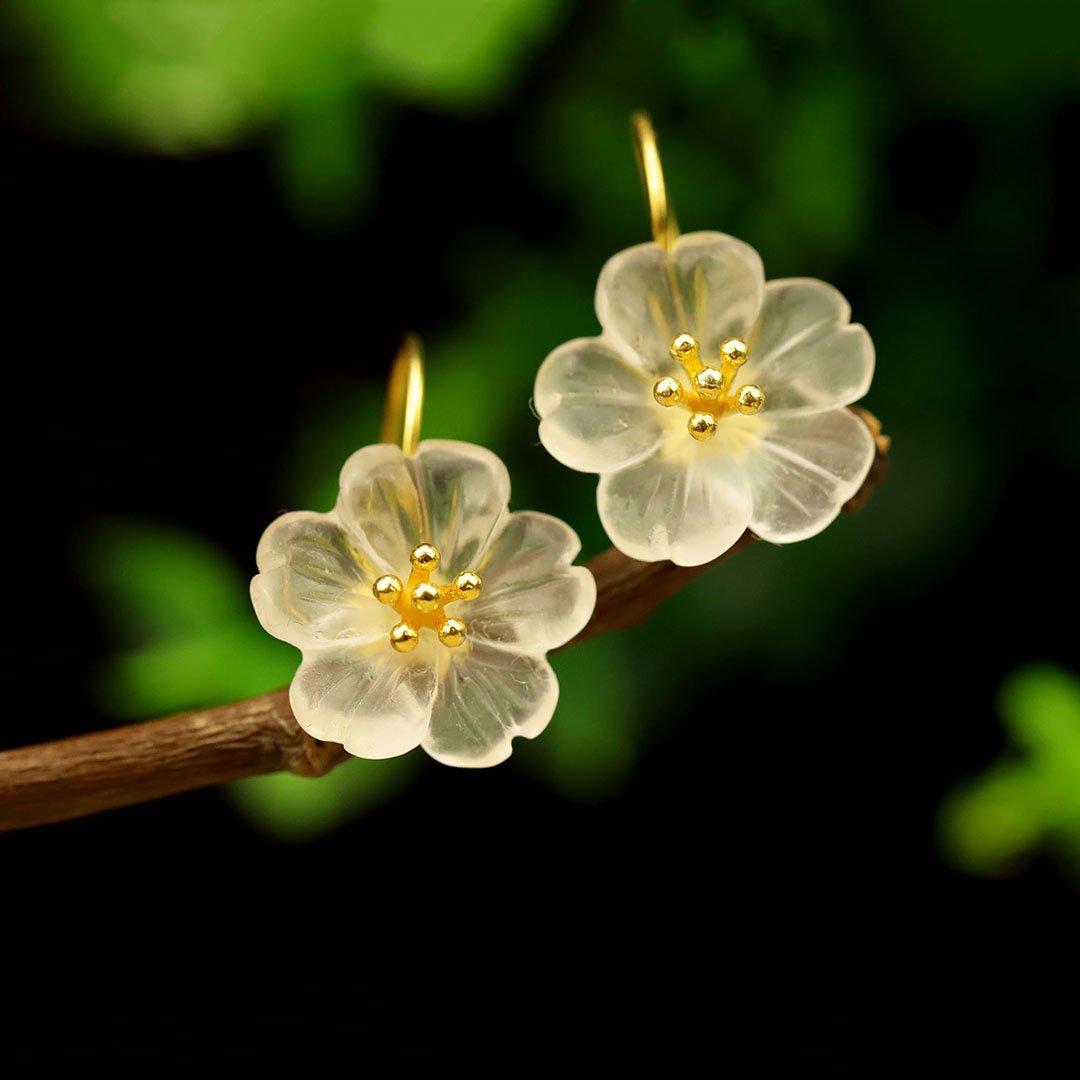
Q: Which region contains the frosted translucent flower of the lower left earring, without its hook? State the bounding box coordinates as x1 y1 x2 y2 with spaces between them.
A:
252 440 596 767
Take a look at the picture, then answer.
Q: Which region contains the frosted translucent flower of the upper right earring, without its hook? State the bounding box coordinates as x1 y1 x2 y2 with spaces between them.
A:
535 232 875 566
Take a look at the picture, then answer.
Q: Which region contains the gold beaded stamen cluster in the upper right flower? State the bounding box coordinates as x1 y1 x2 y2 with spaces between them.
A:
652 334 765 442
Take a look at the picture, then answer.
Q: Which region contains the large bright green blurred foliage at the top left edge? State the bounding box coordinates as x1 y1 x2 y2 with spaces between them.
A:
13 0 563 217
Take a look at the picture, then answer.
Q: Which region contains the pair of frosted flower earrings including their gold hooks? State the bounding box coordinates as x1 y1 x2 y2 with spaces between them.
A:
252 114 875 767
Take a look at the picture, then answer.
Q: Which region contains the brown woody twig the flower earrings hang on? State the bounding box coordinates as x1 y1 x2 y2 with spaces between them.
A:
0 407 889 832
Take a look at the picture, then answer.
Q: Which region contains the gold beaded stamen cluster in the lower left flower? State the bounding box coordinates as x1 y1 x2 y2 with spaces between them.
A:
372 543 483 652
